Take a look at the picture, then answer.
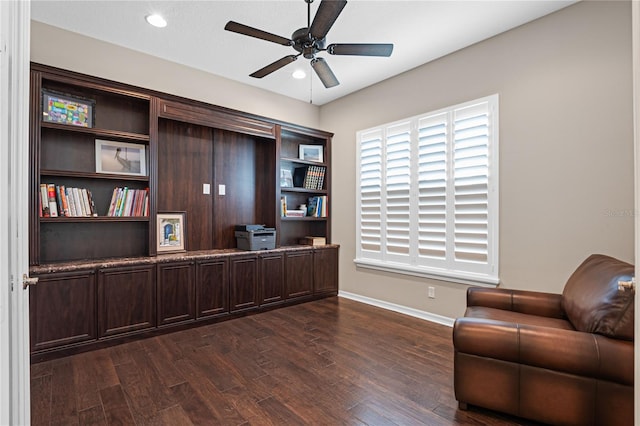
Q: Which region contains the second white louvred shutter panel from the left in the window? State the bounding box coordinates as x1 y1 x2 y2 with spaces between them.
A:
384 123 411 256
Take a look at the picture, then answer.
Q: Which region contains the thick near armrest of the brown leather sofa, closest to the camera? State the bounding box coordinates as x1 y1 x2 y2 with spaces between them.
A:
453 318 634 385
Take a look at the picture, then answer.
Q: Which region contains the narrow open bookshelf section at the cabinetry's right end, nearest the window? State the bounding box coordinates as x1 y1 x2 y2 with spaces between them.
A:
278 126 331 246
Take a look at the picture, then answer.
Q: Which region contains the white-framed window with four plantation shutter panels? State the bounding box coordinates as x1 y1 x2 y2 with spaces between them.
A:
355 95 499 285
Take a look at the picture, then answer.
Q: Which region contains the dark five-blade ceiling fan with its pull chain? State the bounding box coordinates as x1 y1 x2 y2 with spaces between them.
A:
224 0 393 88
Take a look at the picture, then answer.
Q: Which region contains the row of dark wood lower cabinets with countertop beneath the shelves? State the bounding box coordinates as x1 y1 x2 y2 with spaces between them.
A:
30 245 339 363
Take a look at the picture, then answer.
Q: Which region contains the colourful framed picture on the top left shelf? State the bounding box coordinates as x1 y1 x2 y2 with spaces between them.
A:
42 90 95 127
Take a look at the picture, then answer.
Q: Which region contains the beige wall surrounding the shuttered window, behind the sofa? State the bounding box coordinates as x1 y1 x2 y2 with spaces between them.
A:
321 2 634 318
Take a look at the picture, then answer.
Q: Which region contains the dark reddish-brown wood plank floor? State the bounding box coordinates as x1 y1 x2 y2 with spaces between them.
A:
31 297 540 426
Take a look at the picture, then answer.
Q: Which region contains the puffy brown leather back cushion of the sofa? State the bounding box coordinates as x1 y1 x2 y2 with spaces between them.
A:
561 254 635 340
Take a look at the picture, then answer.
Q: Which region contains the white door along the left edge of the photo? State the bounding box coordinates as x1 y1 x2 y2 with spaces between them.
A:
0 0 31 425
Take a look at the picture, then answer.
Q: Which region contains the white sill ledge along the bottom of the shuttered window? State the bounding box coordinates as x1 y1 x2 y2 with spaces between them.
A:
353 259 500 287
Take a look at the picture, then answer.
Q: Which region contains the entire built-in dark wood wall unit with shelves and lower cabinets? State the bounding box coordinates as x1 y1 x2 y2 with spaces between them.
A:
29 64 338 359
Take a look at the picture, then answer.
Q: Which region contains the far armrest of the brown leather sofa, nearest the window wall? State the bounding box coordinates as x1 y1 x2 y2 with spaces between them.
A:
467 287 566 319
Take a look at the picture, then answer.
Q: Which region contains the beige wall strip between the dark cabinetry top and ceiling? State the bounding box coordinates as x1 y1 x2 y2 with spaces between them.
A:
31 21 320 128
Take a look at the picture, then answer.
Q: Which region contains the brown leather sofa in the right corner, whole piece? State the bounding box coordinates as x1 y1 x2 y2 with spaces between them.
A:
453 255 635 426
